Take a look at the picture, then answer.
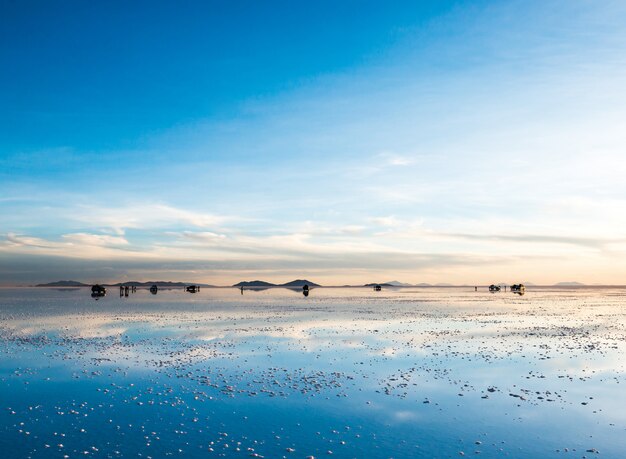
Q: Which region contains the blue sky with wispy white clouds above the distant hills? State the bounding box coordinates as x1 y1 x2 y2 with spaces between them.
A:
0 0 626 285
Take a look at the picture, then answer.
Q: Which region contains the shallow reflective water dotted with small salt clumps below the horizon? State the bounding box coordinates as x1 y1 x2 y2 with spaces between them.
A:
0 288 626 458
